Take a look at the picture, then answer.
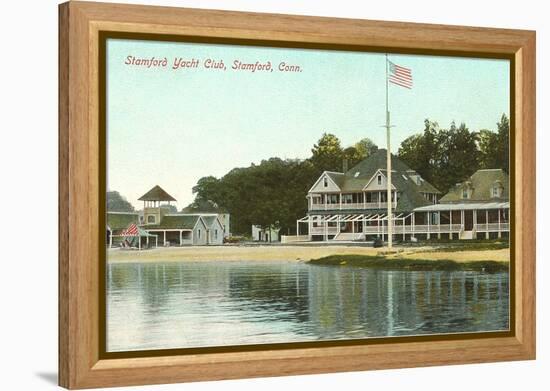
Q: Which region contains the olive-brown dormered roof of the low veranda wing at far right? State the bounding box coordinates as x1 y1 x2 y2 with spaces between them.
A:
440 168 510 203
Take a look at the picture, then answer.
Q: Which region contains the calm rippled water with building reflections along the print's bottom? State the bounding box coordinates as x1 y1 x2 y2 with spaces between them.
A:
107 262 509 351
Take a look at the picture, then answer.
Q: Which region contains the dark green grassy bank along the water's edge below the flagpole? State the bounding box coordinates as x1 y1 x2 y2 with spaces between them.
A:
308 254 509 273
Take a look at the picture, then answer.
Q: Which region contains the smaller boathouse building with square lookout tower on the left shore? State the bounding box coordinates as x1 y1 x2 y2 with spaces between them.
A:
107 186 229 248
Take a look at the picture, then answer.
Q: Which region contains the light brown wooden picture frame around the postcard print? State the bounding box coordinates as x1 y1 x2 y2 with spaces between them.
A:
59 1 535 389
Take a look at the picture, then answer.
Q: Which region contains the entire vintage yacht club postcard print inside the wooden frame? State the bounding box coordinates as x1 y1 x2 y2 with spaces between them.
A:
105 38 511 352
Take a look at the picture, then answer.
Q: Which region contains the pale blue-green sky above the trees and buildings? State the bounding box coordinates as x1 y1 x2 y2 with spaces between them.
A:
107 39 510 209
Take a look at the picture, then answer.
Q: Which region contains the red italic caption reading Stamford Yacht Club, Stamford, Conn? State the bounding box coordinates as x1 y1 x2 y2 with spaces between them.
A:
124 55 303 73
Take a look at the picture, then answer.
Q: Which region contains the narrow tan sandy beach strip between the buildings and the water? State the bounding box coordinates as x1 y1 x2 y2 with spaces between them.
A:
107 245 510 263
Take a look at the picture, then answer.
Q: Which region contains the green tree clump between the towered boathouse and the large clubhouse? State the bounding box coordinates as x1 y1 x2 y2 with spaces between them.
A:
183 133 378 235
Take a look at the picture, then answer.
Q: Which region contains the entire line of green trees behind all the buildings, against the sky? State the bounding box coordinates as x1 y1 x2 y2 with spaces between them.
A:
107 114 510 235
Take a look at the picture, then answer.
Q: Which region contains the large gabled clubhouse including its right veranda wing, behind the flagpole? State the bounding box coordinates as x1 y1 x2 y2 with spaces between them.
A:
298 149 510 241
